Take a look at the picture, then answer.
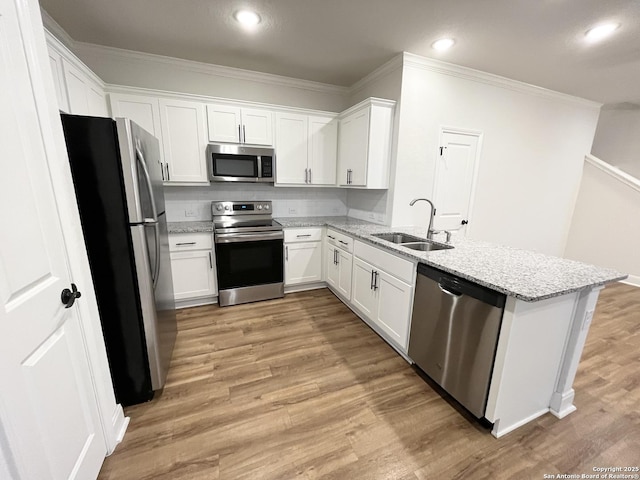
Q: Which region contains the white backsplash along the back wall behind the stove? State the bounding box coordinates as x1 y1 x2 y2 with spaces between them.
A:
164 183 347 222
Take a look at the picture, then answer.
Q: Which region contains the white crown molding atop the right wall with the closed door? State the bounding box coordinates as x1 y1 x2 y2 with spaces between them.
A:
402 52 602 109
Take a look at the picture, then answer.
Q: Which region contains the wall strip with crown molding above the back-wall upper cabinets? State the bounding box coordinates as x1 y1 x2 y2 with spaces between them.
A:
72 43 347 112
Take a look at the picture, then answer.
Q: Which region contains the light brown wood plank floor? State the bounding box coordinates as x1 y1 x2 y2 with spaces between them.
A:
99 284 640 480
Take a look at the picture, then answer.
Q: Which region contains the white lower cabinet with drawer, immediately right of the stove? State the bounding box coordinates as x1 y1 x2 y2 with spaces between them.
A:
284 227 322 286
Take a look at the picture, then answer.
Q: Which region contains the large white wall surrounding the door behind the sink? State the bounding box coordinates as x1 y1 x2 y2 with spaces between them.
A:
387 55 599 255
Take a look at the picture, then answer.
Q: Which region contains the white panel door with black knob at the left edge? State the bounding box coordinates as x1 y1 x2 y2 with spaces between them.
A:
0 0 106 480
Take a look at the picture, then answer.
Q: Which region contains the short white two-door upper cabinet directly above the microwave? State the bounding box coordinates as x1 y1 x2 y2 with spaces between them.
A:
207 104 273 145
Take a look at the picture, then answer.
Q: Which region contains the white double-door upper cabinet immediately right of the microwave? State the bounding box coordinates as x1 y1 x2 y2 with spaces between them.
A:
276 112 338 185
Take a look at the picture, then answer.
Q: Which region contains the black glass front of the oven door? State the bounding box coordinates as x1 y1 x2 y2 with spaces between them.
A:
216 239 284 290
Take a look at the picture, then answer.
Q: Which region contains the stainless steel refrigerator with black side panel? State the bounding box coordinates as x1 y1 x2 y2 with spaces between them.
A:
62 114 176 405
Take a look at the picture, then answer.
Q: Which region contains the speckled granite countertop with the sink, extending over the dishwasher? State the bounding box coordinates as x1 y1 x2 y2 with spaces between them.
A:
276 217 627 302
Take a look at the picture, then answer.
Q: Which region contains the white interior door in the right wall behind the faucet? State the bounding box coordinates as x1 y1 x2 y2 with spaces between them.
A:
434 130 480 232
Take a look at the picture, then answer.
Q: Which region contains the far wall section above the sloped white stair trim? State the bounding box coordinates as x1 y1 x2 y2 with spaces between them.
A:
591 103 640 178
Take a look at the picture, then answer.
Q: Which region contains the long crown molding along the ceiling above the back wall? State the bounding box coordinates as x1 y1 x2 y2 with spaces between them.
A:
74 42 349 96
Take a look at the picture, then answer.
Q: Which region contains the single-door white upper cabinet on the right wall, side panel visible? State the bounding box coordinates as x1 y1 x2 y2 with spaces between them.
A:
338 98 395 188
